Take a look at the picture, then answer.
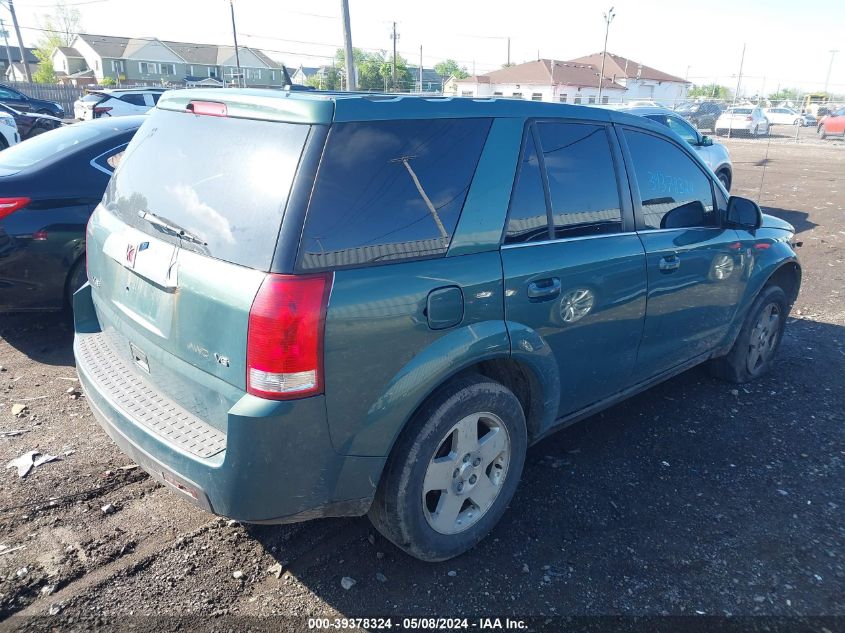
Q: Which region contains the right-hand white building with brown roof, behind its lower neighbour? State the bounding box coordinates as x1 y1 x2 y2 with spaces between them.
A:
572 53 690 105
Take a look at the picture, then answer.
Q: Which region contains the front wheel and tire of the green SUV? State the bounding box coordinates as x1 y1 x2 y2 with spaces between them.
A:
710 285 789 384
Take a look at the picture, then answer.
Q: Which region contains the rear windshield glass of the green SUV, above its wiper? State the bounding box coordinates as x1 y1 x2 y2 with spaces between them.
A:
104 110 310 270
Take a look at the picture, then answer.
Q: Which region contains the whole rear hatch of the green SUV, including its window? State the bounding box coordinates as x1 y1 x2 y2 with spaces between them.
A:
88 94 320 430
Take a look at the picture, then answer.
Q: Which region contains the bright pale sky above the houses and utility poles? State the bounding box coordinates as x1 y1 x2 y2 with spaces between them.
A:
11 0 845 95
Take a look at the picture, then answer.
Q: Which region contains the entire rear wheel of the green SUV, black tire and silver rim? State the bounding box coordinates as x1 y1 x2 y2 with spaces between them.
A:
369 375 528 562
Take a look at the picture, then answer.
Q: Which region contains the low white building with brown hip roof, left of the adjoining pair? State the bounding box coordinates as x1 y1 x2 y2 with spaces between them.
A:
454 59 625 104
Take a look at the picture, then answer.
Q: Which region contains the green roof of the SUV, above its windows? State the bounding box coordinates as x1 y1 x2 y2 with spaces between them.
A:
157 88 665 133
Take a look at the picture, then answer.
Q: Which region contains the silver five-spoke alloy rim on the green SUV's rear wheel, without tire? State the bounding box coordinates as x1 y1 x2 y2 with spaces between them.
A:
422 412 511 534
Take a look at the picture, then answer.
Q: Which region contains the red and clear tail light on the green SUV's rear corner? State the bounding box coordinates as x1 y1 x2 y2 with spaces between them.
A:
246 273 332 400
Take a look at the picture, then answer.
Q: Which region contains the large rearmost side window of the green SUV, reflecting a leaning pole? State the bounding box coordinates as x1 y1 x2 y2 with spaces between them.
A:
299 119 491 269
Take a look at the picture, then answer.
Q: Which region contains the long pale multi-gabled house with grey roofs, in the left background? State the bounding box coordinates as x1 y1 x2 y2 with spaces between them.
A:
53 33 284 88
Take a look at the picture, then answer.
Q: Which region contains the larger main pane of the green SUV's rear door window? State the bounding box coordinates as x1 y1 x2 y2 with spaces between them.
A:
537 123 622 239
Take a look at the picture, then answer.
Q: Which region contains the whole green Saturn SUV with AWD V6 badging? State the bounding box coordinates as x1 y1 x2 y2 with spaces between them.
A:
74 90 801 561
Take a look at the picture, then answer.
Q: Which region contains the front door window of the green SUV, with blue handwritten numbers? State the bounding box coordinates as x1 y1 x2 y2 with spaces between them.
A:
625 130 718 230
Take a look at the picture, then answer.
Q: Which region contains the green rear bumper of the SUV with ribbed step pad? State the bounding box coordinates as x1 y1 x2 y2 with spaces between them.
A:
74 285 384 523
